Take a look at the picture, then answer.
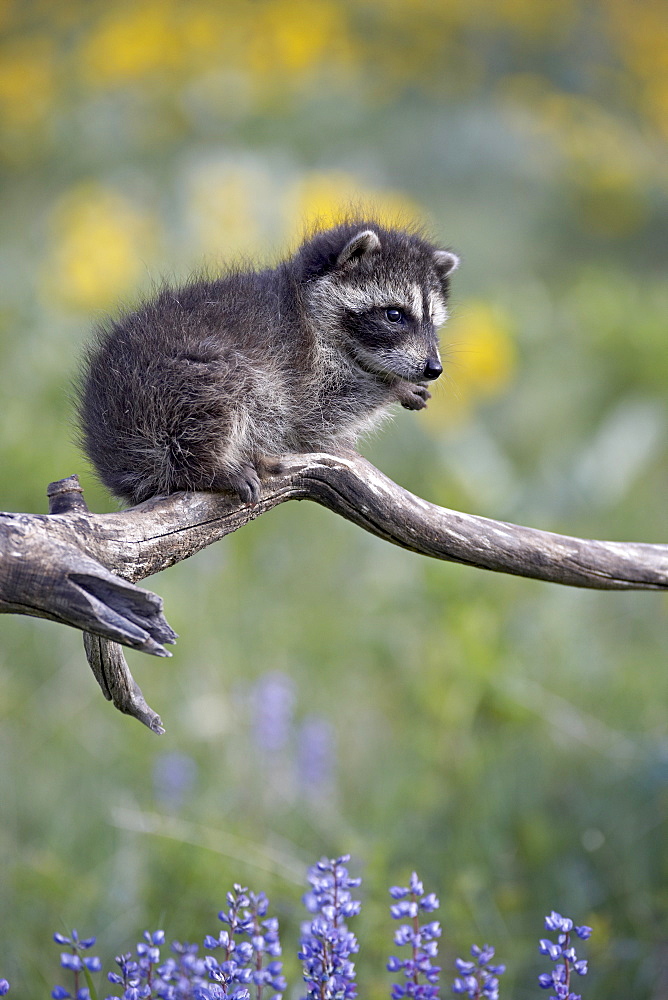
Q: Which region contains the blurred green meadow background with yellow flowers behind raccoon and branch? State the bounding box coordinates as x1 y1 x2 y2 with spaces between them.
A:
0 0 668 1000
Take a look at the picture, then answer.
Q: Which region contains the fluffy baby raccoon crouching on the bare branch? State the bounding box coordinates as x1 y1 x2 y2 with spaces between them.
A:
77 222 458 503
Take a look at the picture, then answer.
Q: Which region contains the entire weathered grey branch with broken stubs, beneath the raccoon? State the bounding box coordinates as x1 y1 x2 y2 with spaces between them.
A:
0 453 668 732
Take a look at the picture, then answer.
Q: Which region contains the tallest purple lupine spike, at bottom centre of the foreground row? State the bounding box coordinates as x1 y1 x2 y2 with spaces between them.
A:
298 854 361 1000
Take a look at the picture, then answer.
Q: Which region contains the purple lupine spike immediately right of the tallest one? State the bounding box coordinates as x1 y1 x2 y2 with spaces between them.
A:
387 872 441 1000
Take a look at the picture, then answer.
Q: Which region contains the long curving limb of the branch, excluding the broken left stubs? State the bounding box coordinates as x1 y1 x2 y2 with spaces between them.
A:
44 454 668 590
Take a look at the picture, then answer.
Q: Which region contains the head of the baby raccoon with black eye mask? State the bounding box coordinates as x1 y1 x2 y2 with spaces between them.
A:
297 222 459 382
